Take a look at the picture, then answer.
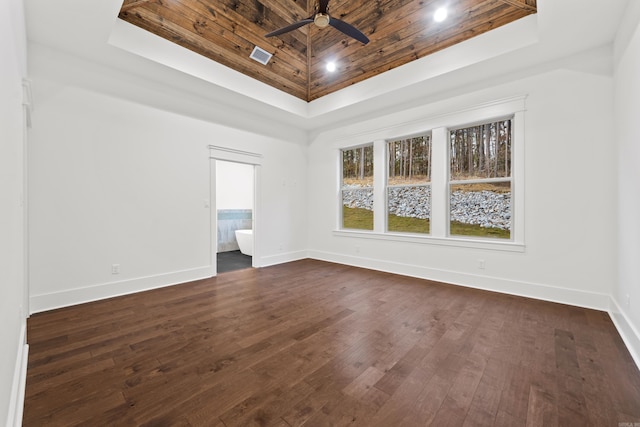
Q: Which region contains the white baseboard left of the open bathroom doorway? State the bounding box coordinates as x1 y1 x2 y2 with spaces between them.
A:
29 266 213 314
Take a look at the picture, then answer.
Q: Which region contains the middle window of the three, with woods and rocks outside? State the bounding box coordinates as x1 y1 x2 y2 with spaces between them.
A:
387 134 431 234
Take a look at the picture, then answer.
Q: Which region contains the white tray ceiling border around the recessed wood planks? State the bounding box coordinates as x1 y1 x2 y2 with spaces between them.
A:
24 0 629 132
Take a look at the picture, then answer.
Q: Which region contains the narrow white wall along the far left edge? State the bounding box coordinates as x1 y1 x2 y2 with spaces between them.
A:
0 0 26 425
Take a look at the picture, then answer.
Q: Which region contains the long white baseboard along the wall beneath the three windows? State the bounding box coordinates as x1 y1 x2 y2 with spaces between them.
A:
309 251 609 311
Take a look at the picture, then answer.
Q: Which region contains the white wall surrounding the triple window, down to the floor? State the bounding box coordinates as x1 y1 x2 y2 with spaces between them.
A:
308 49 616 309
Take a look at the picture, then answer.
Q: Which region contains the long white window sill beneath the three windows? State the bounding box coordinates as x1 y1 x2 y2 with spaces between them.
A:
333 230 525 252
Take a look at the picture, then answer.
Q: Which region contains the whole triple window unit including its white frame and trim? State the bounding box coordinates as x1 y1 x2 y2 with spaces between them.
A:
335 95 526 252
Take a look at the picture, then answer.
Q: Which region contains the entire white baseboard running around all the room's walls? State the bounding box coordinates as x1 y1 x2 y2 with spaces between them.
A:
25 251 640 376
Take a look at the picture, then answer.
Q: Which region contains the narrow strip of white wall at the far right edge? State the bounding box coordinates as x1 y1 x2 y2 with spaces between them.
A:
612 2 640 364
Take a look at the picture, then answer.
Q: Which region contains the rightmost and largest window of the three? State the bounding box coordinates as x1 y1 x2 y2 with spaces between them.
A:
449 118 512 239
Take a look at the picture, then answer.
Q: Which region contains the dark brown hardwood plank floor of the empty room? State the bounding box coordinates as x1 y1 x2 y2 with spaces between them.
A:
24 260 640 427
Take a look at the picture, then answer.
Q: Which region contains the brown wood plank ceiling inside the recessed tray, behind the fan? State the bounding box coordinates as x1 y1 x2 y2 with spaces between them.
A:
119 0 537 102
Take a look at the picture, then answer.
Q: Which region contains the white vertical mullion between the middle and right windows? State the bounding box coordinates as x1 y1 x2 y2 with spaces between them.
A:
431 127 449 241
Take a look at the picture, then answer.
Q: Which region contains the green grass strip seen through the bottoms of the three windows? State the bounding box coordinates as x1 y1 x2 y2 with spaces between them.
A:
342 206 511 239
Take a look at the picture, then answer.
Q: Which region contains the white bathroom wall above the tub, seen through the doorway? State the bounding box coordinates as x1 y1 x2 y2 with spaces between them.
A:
216 161 254 210
